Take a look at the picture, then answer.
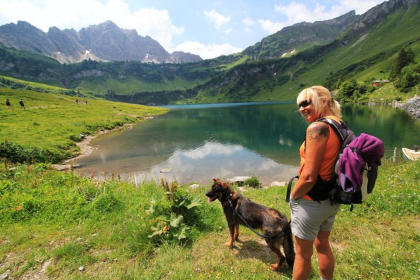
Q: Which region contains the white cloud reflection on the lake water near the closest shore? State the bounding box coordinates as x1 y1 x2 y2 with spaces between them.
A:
125 142 297 184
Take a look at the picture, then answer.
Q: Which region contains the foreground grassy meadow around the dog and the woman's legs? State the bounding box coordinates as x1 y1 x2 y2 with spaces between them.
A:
0 161 420 279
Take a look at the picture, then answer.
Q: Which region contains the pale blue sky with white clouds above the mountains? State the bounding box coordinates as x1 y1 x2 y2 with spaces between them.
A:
0 0 384 59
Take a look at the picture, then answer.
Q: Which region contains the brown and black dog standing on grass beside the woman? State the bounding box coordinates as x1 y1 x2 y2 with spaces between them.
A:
206 179 295 270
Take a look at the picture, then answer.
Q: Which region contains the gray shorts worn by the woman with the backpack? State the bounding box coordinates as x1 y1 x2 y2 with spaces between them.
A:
290 198 340 240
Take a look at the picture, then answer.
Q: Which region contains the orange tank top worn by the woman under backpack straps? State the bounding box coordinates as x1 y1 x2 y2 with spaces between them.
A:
298 116 341 181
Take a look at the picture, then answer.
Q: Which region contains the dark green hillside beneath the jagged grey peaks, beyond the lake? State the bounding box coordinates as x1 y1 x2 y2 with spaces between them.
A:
0 44 226 97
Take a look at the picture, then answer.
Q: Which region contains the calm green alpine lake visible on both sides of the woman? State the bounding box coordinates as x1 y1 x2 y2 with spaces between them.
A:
75 102 420 184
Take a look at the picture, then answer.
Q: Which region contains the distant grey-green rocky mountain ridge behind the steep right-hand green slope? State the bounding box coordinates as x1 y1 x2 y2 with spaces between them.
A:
242 11 359 60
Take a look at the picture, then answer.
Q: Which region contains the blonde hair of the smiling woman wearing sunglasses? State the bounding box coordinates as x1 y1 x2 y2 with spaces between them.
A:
296 86 341 119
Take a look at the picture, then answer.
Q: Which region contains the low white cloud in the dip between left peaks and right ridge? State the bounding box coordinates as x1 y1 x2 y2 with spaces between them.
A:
175 41 242 59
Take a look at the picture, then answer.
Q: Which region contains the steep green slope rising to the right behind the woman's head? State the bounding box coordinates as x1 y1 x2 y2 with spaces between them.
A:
186 1 420 102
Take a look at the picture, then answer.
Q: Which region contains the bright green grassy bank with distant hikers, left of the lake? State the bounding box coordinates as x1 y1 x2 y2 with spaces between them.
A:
0 81 166 162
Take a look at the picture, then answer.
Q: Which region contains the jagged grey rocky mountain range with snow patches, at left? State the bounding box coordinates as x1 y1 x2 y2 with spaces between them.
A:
0 21 201 63
